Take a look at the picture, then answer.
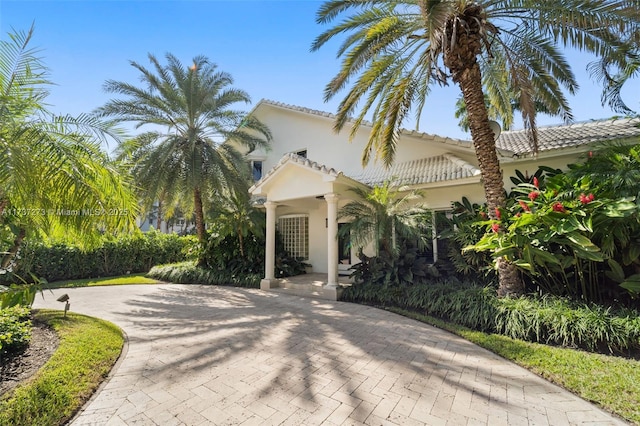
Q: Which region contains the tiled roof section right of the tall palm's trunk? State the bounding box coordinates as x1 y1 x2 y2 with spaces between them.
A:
496 118 640 155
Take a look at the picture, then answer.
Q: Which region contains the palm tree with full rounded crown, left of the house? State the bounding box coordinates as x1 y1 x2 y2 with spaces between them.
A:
98 54 271 241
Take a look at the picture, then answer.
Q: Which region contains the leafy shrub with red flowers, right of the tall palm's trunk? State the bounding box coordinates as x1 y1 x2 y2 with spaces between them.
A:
467 162 640 302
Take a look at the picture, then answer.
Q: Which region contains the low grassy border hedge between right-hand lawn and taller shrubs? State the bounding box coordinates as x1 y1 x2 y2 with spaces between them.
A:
342 283 640 355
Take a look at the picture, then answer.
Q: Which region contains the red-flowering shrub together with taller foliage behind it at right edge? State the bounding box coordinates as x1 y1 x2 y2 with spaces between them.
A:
452 146 640 303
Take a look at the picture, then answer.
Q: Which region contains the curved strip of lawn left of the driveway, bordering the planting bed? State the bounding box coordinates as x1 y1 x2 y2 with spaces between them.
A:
0 310 124 426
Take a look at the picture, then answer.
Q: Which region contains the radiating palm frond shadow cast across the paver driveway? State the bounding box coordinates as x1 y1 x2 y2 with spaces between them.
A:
104 285 564 422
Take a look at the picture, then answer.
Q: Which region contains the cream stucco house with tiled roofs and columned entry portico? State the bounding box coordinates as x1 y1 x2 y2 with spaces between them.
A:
239 100 640 299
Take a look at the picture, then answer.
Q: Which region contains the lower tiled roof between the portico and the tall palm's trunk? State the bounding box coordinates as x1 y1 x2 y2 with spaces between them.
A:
353 154 480 185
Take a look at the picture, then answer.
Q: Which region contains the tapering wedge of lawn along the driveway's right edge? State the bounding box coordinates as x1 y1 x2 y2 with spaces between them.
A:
387 308 640 424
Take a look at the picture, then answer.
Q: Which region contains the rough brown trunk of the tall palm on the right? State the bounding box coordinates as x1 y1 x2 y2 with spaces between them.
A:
456 61 524 297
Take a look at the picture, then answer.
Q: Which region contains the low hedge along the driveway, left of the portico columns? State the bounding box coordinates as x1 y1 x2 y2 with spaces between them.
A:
147 262 263 288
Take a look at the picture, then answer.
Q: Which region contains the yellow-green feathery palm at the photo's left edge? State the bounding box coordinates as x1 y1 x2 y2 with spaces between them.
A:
0 26 137 268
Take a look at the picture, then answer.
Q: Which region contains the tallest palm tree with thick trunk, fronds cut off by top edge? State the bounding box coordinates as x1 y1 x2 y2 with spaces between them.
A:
312 0 640 295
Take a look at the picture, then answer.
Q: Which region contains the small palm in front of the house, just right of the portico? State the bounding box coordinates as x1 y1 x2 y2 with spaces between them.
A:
338 181 431 256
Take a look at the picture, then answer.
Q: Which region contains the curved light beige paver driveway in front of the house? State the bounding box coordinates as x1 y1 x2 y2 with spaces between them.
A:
35 284 625 426
